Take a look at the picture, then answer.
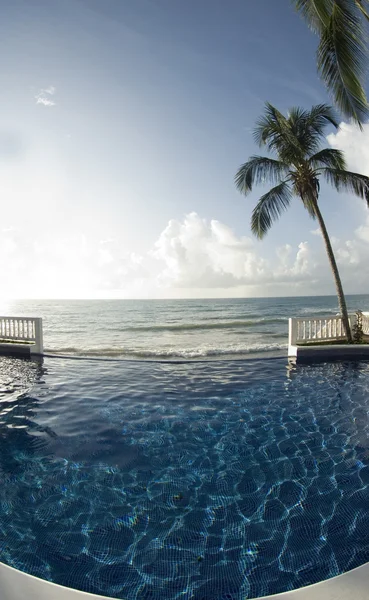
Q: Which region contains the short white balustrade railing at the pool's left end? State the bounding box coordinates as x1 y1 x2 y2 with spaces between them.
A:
0 316 43 354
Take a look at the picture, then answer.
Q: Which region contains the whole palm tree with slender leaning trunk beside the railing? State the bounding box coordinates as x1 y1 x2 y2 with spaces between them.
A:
235 103 369 342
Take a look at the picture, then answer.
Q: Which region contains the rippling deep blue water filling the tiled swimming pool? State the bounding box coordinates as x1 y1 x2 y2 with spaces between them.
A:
0 358 369 600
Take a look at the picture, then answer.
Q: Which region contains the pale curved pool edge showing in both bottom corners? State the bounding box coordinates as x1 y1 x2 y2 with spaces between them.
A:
0 563 369 600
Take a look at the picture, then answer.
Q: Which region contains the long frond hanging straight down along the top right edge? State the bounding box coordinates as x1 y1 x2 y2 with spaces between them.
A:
317 0 369 126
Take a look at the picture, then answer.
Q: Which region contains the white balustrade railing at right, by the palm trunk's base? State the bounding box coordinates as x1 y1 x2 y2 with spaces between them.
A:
289 314 354 346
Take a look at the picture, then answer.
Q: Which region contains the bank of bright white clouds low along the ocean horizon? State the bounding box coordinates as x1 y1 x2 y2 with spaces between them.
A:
0 213 369 298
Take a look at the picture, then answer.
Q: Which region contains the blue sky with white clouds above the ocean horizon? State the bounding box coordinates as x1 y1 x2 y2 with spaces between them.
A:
0 0 369 298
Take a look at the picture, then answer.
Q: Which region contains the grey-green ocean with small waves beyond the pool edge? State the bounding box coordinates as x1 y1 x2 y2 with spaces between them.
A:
1 295 369 360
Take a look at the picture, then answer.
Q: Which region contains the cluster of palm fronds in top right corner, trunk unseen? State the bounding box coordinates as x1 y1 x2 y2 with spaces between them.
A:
292 0 369 127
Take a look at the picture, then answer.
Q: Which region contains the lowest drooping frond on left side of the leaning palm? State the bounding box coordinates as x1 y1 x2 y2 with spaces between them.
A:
251 181 292 239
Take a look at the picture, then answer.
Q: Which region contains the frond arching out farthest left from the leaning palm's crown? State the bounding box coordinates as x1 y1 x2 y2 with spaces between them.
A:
235 156 288 196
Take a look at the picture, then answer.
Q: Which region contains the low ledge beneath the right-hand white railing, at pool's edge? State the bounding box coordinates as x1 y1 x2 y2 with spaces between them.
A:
288 344 369 364
